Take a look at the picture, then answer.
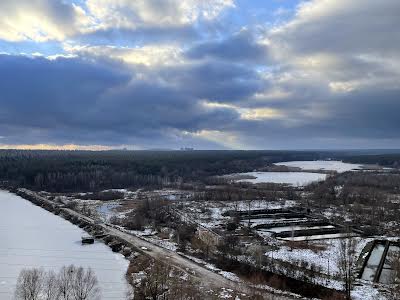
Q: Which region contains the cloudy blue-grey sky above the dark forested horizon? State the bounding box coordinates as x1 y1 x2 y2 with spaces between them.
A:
0 0 400 150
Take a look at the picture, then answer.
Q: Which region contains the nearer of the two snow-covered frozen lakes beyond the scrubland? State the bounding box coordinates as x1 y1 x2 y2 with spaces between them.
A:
237 172 326 186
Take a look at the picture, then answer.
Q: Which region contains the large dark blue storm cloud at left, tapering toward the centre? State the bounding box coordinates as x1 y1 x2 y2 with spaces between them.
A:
0 55 238 144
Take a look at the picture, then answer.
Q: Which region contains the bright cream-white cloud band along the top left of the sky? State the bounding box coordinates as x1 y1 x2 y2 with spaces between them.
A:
0 0 234 42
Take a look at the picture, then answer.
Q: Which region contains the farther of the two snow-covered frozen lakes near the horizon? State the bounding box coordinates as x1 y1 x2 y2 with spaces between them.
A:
275 160 362 173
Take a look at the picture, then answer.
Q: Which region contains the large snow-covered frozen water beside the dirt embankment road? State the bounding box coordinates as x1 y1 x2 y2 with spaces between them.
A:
0 191 128 299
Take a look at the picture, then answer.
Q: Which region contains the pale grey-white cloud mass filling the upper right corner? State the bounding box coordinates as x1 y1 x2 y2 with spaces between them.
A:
259 0 400 102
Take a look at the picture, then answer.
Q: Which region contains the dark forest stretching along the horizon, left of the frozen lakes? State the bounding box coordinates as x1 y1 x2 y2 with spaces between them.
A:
0 150 325 192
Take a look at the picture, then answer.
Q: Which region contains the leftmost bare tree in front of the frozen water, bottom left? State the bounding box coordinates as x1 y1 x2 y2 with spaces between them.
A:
15 269 44 300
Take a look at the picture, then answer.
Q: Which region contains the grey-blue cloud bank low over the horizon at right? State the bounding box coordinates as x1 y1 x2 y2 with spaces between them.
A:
223 89 400 148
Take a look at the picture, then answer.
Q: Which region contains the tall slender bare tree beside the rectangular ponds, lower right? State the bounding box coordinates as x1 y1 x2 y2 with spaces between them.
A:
338 234 356 299
